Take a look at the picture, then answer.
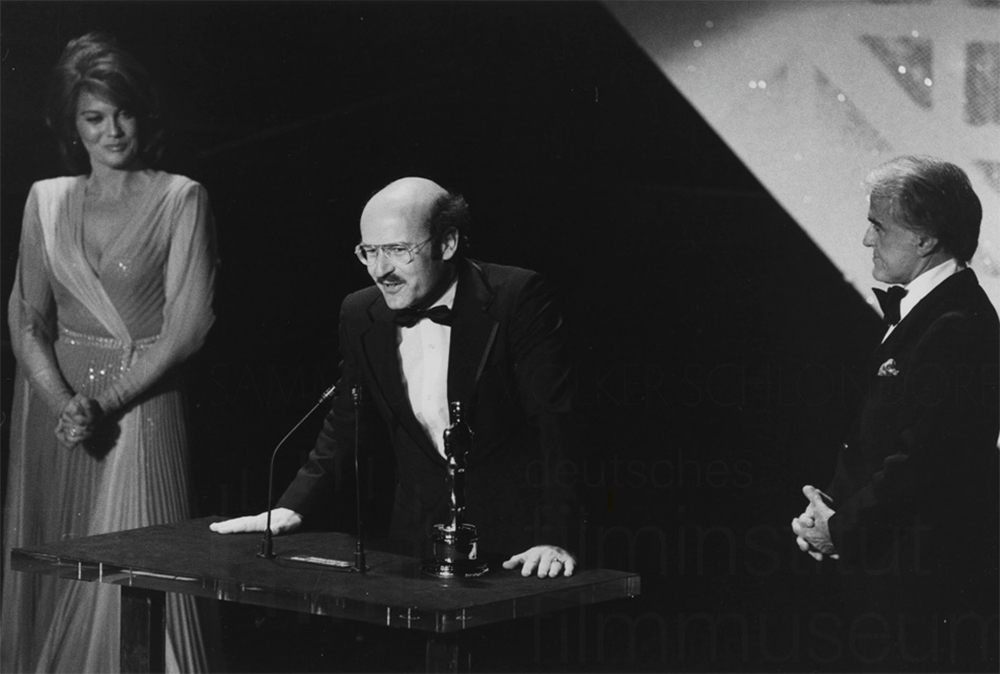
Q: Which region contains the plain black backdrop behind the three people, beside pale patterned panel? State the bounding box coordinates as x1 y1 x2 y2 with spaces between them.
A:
0 1 879 671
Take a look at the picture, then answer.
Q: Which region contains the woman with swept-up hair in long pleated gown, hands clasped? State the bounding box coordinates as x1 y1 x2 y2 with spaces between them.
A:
0 34 215 672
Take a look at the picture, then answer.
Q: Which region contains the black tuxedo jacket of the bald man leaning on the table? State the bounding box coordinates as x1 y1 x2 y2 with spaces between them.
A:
278 260 576 554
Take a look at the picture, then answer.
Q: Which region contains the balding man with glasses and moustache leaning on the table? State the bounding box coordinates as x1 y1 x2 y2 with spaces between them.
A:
212 177 576 577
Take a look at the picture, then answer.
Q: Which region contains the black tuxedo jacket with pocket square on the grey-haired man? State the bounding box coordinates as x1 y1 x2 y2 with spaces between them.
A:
827 269 1000 606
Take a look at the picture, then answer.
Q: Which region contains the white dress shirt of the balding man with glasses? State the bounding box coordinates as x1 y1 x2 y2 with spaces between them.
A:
396 279 458 457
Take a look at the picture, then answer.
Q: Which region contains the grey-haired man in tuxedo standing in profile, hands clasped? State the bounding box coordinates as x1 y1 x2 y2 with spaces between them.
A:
792 156 1000 644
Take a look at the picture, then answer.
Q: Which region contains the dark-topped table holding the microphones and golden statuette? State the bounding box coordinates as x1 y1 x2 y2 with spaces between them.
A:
11 517 640 672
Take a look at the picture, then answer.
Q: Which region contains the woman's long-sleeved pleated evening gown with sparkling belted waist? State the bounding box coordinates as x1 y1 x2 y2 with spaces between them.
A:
0 172 215 672
